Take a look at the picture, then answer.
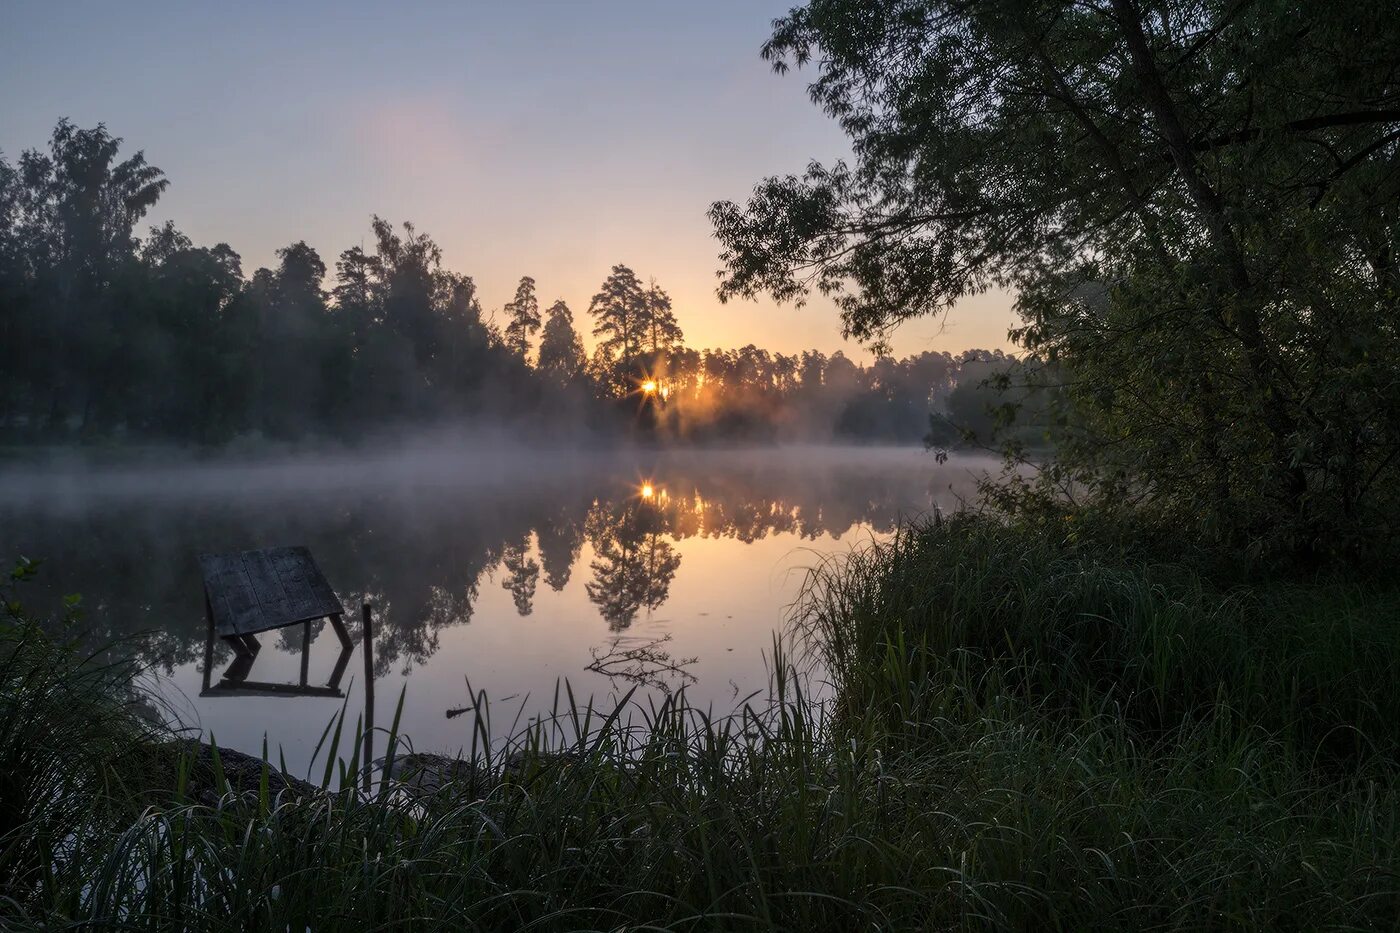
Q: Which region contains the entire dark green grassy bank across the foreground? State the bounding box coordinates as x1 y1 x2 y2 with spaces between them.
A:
0 518 1400 930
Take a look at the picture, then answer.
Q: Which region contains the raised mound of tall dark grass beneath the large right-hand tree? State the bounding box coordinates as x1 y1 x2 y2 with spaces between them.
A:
798 516 1400 762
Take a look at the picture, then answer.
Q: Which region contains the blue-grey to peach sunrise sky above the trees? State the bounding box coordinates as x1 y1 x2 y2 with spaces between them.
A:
0 0 1014 359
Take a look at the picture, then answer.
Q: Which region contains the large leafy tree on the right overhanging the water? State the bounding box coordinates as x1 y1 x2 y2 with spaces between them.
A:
711 0 1400 553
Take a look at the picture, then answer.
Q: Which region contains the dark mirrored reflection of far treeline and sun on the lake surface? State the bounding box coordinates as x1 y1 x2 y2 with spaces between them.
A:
0 459 952 664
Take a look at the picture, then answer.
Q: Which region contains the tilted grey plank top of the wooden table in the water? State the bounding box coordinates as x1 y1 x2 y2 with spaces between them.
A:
199 548 344 636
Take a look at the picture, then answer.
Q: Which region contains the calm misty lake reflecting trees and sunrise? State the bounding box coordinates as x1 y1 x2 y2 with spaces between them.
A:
0 441 997 773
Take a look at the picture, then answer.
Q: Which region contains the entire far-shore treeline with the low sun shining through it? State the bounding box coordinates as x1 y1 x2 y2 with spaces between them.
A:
0 120 1014 444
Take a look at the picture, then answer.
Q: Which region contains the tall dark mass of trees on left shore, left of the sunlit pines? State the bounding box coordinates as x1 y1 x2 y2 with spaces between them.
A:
0 120 563 443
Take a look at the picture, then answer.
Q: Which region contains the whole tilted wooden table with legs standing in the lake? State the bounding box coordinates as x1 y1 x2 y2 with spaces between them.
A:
199 548 351 696
